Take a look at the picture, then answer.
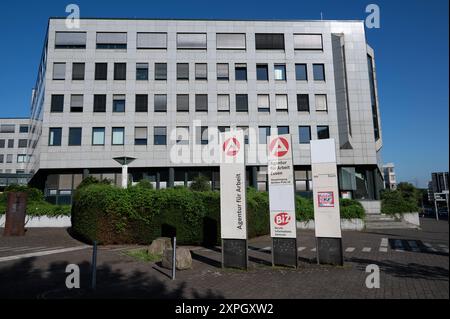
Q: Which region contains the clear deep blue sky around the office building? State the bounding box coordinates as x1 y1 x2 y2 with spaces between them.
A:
0 0 449 187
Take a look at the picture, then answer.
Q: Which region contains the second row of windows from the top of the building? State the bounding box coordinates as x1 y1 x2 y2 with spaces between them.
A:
53 62 325 81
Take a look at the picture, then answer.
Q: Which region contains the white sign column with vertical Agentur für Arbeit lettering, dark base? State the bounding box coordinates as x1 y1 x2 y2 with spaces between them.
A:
220 131 248 269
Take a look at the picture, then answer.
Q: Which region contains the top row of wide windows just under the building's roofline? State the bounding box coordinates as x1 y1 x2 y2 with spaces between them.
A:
55 31 323 50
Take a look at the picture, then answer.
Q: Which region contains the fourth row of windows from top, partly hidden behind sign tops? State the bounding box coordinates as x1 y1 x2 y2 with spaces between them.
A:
48 126 330 146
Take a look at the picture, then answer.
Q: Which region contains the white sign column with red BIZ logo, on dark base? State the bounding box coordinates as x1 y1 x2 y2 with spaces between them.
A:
267 135 298 268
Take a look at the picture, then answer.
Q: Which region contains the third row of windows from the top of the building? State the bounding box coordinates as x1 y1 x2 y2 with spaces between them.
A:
50 94 328 113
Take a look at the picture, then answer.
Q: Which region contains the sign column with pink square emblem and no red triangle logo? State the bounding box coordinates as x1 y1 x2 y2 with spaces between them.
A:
311 139 344 265
